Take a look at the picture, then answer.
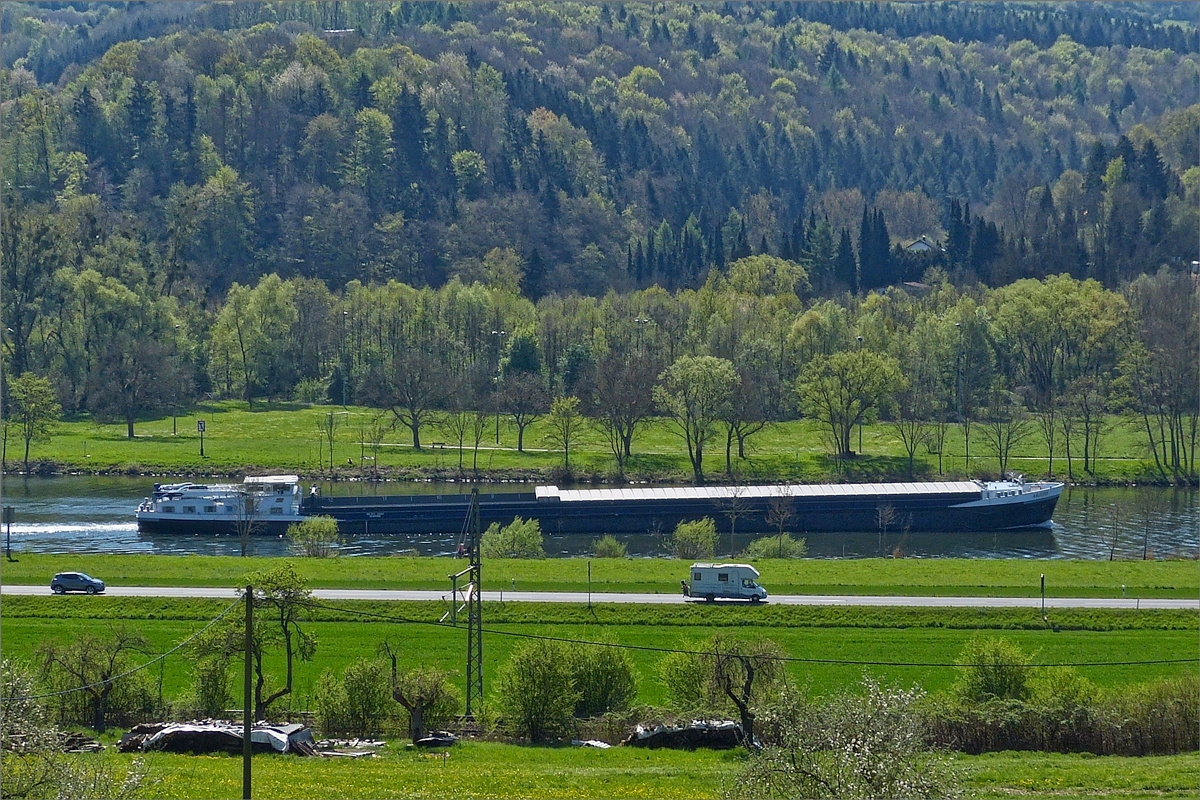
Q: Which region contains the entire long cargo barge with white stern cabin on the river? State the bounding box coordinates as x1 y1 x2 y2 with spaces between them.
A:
137 475 1063 535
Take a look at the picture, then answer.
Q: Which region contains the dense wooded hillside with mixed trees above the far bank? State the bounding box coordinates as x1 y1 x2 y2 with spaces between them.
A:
0 2 1200 480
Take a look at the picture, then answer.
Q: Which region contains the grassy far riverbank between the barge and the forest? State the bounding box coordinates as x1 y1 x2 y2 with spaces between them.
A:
7 402 1176 483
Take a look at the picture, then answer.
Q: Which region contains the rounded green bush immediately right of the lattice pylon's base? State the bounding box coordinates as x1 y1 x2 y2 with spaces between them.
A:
497 640 580 744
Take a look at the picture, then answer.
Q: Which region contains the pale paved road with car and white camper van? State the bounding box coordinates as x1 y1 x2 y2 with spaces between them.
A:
0 585 1200 609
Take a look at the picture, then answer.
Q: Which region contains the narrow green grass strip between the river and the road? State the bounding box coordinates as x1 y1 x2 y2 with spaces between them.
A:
0 554 1200 597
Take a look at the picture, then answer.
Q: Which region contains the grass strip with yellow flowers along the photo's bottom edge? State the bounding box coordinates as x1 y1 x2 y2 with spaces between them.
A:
42 742 1200 800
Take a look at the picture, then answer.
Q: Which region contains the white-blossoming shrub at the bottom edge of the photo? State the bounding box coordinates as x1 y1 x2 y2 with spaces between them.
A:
730 678 956 798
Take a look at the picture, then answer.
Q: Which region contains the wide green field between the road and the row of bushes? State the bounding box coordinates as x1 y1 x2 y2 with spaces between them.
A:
0 596 1200 711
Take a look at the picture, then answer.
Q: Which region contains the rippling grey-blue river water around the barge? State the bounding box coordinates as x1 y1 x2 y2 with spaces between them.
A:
0 476 1200 569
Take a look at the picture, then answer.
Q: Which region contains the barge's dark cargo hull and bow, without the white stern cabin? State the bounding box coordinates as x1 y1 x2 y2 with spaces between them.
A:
302 479 1063 535
